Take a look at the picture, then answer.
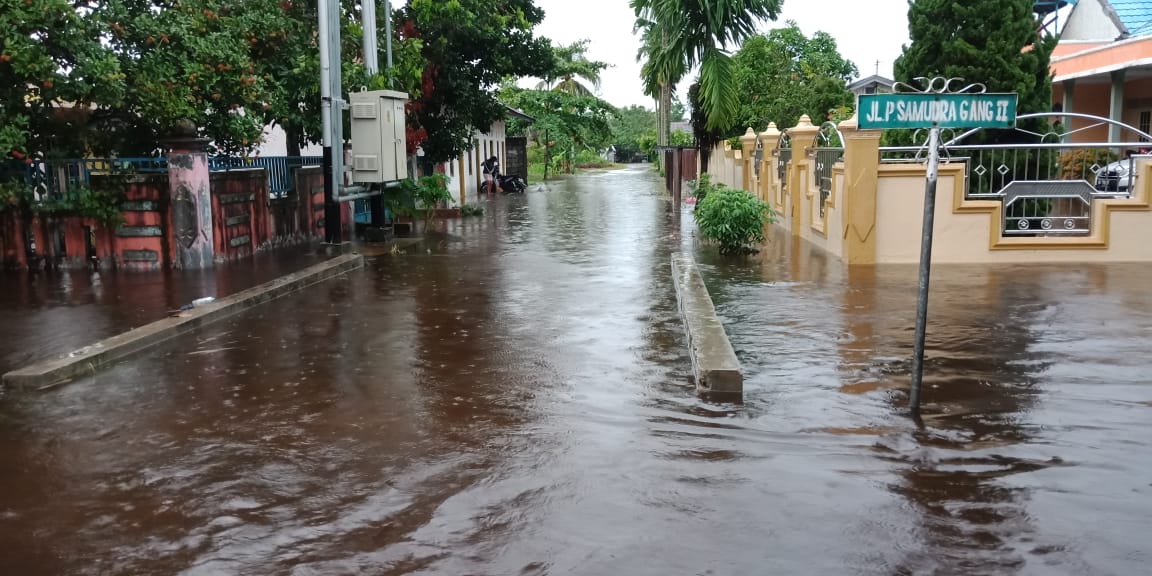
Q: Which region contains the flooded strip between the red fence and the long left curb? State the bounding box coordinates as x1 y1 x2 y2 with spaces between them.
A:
0 245 328 373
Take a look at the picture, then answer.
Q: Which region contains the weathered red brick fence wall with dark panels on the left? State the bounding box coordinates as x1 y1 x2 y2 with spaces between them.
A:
0 166 353 270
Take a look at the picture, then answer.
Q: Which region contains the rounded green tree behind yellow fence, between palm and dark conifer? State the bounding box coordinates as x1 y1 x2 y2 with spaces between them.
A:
726 21 858 131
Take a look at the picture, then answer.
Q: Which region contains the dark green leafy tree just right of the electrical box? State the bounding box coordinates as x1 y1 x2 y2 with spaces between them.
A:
400 0 554 162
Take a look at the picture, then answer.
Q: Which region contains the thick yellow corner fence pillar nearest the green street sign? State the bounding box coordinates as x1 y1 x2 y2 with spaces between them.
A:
840 114 884 265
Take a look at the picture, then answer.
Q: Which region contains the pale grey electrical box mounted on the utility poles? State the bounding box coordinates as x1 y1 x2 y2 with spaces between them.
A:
348 90 408 183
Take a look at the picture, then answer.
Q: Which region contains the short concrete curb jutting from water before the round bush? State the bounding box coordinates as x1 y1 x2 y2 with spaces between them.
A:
672 255 744 401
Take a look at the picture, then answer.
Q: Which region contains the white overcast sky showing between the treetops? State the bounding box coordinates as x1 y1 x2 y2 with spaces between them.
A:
524 0 908 107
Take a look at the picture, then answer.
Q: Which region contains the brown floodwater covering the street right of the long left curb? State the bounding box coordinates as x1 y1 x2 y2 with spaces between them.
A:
0 164 1152 576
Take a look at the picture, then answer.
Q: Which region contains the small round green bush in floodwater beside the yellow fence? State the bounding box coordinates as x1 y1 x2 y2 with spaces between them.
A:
695 182 774 255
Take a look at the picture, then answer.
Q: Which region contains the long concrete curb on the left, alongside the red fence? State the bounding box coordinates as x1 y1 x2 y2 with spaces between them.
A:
3 255 364 388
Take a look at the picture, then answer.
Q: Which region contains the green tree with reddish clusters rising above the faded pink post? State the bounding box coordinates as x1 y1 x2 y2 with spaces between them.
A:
92 0 311 154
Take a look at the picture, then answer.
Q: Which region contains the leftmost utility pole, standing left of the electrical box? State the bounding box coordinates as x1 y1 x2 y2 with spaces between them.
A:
316 0 344 244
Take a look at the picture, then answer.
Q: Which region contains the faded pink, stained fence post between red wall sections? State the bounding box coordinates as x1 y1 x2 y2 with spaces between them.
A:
166 123 215 270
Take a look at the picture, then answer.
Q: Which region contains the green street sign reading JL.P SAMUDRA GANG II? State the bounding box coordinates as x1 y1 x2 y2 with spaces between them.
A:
858 92 1016 130
